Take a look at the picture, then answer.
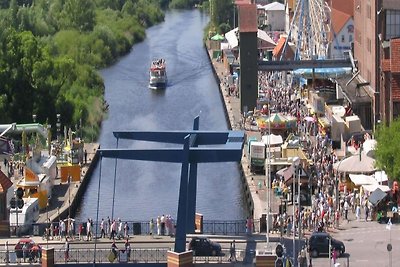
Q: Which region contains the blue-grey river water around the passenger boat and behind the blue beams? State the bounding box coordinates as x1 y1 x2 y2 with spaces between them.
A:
76 10 246 221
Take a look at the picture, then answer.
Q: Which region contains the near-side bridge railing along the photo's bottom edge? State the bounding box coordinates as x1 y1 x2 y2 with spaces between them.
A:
0 248 255 266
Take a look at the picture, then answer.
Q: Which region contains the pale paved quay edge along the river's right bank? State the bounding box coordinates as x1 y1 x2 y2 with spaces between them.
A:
205 48 280 228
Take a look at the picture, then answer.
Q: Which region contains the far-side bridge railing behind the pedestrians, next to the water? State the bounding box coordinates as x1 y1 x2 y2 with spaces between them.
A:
17 220 260 236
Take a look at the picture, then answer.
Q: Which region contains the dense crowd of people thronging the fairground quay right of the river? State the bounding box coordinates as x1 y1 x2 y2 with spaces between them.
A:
253 72 372 239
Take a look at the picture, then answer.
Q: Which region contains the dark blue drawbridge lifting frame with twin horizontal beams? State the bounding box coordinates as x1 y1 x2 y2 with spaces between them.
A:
97 117 244 252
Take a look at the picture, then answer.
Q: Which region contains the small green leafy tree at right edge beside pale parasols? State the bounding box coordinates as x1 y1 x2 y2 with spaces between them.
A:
375 119 400 181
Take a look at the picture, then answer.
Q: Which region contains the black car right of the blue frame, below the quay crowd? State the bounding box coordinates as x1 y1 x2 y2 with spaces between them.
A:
308 232 346 258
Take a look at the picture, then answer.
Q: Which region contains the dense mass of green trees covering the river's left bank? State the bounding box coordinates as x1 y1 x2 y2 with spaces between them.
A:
0 0 169 140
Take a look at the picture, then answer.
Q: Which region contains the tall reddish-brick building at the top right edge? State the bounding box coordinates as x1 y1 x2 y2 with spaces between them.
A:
354 0 400 128
